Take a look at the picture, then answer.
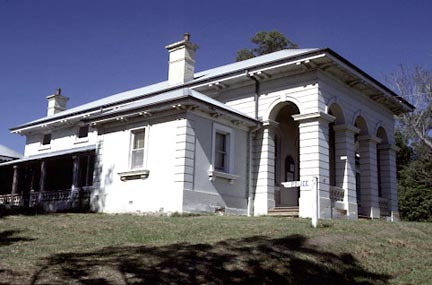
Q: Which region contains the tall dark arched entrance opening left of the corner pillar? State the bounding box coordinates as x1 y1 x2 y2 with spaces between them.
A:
270 102 300 207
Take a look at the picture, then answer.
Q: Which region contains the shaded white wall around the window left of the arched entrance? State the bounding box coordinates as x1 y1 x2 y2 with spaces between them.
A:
183 112 248 214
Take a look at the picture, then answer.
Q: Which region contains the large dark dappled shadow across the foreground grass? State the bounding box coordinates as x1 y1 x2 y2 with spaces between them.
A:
31 235 389 284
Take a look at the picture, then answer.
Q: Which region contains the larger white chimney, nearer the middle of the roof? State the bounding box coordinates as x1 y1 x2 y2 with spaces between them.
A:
165 33 197 85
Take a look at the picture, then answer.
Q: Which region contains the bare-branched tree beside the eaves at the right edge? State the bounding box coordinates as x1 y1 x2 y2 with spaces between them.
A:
387 65 432 151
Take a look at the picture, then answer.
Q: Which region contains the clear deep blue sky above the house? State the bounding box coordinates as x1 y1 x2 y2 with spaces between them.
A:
0 0 432 152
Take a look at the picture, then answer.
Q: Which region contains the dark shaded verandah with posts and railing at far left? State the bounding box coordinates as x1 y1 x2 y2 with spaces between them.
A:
0 147 95 212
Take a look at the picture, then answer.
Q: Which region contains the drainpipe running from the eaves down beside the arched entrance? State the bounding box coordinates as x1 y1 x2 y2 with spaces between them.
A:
246 70 261 216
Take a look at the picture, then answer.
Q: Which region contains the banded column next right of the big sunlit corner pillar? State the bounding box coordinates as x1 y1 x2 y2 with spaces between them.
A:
333 125 360 219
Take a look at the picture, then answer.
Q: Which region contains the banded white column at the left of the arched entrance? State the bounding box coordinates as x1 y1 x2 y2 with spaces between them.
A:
253 121 275 216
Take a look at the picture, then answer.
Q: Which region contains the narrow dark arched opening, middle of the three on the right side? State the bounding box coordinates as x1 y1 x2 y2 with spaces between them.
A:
354 116 369 215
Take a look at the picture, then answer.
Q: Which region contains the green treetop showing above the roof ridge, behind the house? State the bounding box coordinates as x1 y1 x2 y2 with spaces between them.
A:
236 30 298 61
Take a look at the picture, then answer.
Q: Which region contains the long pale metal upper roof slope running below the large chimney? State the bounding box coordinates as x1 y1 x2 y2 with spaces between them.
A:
12 49 319 130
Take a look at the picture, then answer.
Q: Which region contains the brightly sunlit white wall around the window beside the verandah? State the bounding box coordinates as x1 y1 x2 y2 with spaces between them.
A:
95 116 182 213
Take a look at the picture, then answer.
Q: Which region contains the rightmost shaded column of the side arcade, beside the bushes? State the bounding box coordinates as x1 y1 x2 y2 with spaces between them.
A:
378 144 399 220
